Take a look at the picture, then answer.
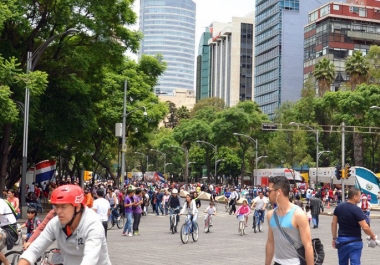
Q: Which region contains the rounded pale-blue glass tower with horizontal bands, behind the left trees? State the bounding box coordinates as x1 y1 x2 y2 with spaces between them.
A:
139 0 196 94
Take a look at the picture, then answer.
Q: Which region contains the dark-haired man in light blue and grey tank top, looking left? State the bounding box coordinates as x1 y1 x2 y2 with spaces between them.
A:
265 176 314 265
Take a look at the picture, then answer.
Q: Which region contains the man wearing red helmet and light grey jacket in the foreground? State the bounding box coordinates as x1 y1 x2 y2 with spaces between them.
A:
18 185 111 265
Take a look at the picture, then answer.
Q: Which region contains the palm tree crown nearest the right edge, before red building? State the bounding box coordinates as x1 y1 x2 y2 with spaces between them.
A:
345 51 370 91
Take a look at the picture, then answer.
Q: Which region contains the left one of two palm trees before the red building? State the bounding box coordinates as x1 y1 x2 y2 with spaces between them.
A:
313 58 335 97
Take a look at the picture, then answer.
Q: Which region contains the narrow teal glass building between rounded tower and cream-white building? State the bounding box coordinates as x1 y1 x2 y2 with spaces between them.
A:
196 27 212 101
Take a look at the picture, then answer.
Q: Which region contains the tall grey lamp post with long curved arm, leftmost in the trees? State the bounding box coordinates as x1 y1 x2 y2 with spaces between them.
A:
20 29 79 217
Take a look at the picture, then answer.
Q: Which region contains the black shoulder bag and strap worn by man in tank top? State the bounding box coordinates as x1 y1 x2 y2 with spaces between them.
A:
273 209 325 265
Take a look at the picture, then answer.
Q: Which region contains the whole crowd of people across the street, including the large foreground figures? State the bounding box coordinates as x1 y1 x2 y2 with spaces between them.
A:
0 177 380 265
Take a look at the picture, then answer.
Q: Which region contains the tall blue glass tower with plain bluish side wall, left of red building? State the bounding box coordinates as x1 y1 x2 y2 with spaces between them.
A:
254 0 329 117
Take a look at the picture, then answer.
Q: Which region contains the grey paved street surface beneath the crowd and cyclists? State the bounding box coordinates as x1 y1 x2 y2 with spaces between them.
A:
104 201 380 265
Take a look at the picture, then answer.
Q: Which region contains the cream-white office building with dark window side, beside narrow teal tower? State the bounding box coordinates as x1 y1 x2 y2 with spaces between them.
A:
209 12 255 107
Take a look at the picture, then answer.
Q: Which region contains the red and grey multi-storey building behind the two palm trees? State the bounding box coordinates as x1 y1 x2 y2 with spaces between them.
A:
304 0 380 91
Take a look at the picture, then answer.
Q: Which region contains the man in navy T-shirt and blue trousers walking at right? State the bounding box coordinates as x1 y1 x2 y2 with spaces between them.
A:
331 188 380 265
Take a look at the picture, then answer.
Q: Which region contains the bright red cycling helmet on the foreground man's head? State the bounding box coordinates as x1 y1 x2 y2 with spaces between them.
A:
50 185 86 206
